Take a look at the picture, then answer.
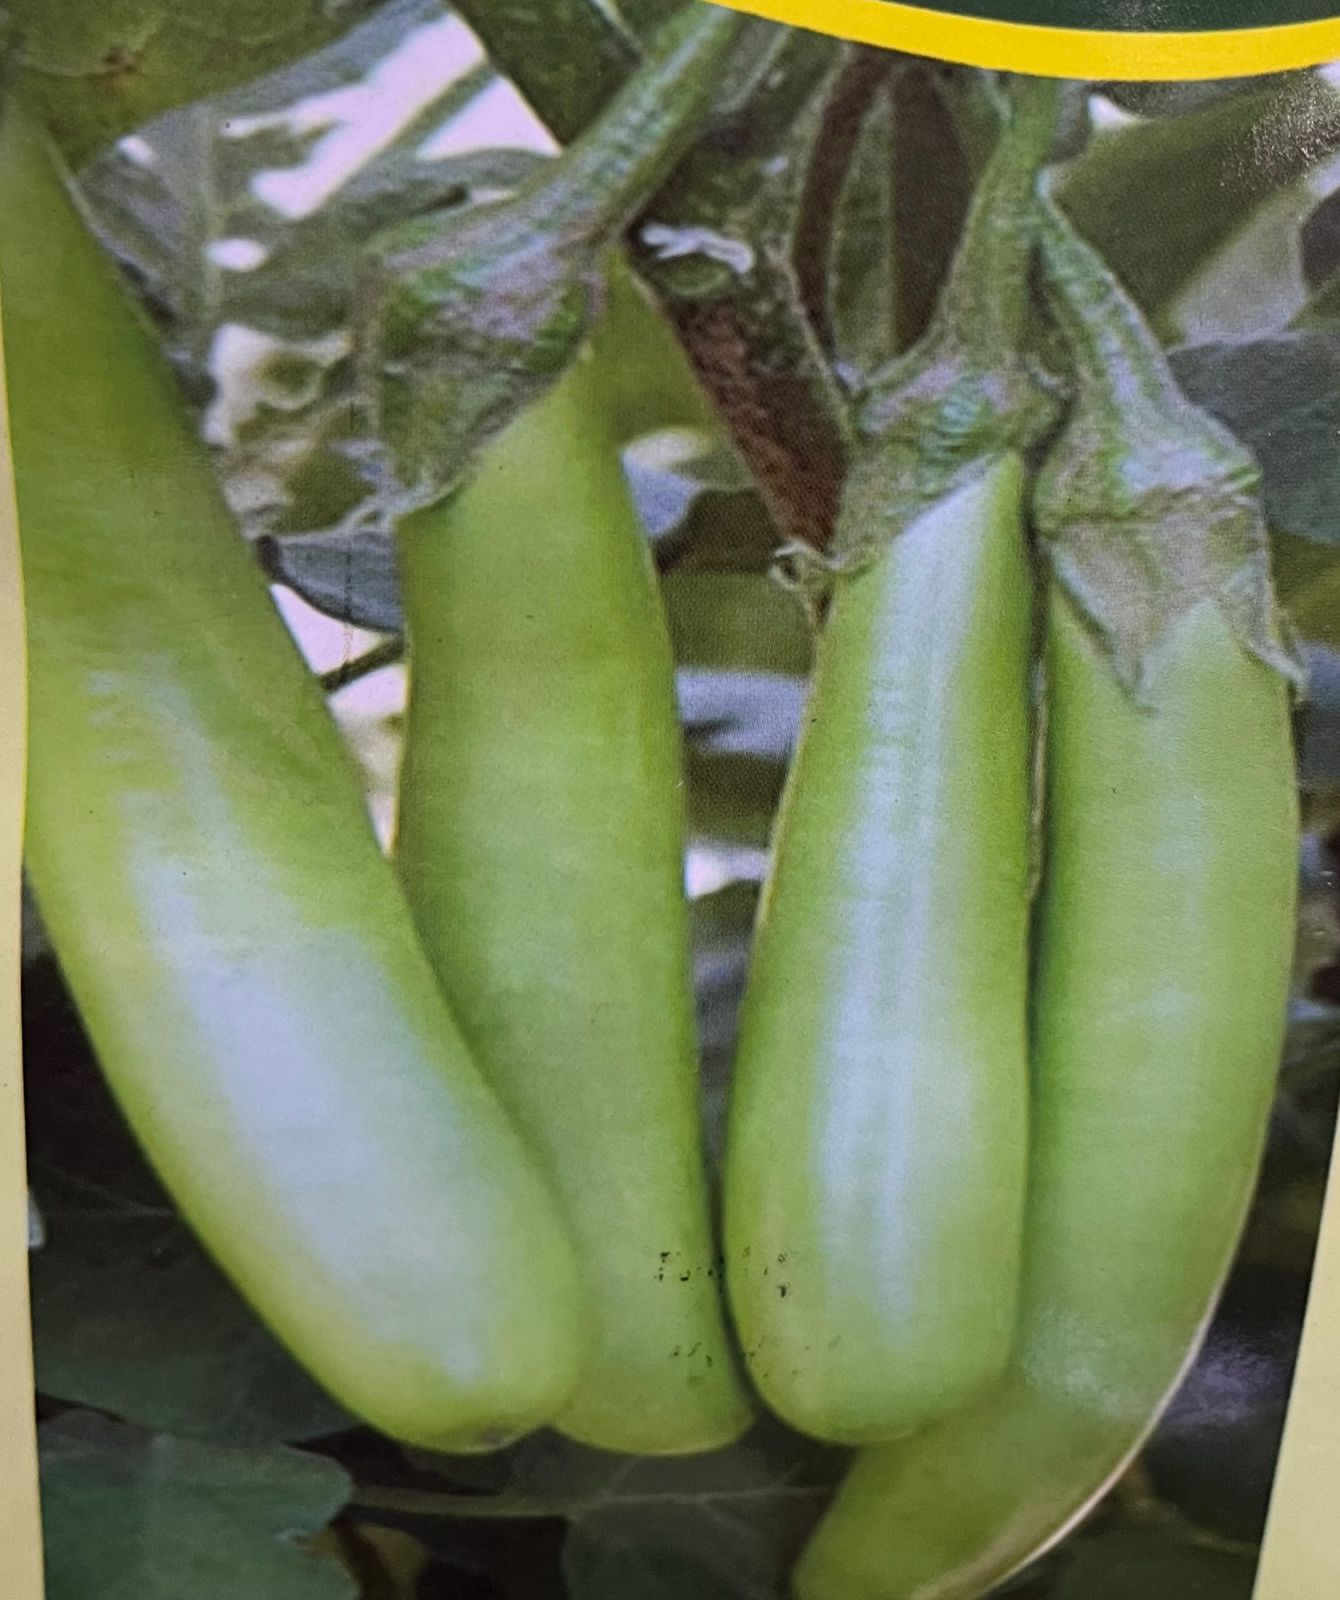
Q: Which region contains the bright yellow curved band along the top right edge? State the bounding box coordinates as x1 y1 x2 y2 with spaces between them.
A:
713 0 1340 83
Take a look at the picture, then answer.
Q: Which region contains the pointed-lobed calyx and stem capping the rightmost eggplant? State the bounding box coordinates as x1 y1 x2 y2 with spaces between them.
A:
1035 203 1303 701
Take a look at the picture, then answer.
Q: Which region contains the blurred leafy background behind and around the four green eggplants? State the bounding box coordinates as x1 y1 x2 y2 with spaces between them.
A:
18 0 1340 1600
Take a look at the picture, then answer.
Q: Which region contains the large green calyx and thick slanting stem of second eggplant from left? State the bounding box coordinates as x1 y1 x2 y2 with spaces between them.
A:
357 6 742 514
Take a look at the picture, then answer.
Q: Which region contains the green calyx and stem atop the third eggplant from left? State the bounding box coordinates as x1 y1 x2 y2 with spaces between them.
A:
828 78 1062 571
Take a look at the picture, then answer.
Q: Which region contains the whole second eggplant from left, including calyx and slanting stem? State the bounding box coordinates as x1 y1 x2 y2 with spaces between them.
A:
385 6 752 1454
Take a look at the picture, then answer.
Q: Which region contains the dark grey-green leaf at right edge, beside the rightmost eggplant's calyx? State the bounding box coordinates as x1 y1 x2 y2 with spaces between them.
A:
1172 331 1340 546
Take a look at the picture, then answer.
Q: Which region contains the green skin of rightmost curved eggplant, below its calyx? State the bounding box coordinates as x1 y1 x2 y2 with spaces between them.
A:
795 590 1298 1600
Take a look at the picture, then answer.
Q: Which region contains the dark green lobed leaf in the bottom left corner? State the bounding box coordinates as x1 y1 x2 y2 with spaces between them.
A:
40 1413 357 1600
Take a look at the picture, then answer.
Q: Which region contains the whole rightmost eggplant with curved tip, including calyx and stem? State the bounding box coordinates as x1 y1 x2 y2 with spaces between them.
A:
796 193 1298 1600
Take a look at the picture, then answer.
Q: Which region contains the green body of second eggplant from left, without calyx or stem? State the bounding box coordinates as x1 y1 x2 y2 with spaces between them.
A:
398 344 750 1454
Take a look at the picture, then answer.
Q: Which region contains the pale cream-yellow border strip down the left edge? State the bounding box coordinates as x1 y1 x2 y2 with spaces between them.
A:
0 294 43 1600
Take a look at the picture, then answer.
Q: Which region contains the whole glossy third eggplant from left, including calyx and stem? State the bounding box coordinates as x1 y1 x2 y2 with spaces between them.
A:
726 85 1055 1443
